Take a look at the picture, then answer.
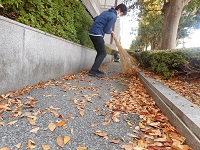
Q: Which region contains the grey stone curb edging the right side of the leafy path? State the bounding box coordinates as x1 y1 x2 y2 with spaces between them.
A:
138 72 200 150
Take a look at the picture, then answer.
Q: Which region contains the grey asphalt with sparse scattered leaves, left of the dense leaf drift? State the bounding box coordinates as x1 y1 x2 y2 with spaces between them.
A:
0 62 139 150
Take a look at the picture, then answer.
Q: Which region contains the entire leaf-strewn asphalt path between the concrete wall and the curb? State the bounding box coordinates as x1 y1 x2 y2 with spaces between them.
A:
0 62 189 150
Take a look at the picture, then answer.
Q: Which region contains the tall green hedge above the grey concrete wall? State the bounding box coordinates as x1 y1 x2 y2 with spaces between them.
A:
0 0 93 48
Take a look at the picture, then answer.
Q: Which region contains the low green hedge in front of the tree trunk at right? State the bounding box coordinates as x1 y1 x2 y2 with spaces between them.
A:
131 48 200 79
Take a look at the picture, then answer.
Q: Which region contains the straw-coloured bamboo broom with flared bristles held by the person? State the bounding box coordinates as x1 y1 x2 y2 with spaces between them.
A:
113 36 139 76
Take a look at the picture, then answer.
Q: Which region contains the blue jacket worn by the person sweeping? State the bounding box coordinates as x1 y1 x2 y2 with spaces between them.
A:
89 8 117 37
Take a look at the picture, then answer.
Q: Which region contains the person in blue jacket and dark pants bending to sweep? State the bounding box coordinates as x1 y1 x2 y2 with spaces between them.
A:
88 4 127 78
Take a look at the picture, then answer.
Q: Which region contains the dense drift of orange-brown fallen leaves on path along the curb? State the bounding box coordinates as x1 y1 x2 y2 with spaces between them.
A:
106 74 191 150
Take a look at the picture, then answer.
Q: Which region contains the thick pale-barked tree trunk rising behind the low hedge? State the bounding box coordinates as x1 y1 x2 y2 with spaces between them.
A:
160 0 190 50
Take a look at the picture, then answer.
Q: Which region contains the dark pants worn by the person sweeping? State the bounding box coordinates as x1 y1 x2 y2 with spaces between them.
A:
90 35 107 71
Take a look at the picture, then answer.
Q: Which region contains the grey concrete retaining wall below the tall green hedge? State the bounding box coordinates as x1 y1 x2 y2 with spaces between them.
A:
0 16 112 94
